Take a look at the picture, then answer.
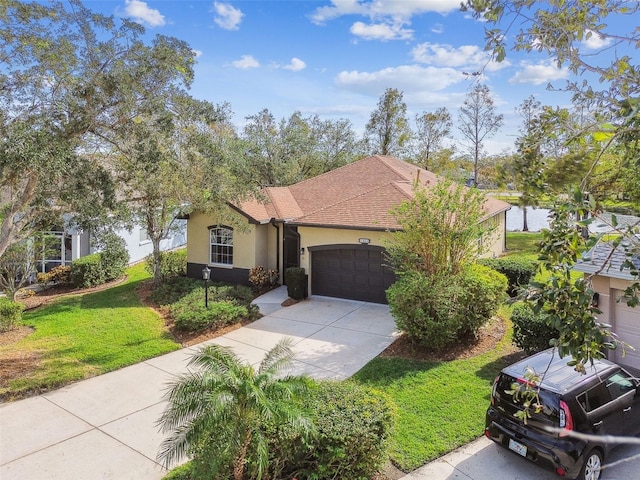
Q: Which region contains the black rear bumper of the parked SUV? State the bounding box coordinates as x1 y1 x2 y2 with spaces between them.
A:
485 408 583 479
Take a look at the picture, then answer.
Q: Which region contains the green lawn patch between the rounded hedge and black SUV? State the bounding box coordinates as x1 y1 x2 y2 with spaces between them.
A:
354 320 513 472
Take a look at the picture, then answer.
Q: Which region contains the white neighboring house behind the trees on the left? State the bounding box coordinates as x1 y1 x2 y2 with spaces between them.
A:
37 220 187 272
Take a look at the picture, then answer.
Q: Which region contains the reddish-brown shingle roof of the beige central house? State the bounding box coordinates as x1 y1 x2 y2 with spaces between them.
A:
236 155 510 230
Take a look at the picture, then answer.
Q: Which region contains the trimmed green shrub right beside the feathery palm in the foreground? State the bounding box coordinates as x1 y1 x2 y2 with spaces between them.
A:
269 381 396 480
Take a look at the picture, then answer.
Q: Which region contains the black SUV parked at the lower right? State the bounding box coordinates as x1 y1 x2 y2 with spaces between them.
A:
485 349 640 480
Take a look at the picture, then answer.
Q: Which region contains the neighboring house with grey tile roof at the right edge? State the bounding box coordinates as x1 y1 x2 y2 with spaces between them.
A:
574 242 640 369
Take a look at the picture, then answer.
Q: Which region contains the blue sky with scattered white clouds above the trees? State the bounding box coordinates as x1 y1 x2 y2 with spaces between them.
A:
85 0 632 153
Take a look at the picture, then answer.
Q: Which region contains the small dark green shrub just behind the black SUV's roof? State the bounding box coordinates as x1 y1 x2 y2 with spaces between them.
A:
511 302 559 355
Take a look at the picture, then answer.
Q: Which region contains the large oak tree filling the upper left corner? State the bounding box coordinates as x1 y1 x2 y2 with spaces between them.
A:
0 0 194 255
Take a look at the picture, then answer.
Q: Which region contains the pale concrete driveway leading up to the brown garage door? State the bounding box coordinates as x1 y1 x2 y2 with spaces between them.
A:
0 288 398 480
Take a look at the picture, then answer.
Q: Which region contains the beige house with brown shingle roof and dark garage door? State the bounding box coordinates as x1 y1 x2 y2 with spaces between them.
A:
187 155 510 303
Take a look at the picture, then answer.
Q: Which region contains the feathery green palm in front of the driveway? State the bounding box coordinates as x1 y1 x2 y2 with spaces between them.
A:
158 338 312 480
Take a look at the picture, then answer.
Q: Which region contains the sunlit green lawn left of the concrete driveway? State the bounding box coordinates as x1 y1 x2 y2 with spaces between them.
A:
0 264 180 399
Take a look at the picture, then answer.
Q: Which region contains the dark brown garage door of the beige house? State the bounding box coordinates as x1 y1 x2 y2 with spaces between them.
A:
309 245 395 303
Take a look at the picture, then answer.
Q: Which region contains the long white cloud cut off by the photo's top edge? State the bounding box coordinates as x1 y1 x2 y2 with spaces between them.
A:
311 0 460 24
